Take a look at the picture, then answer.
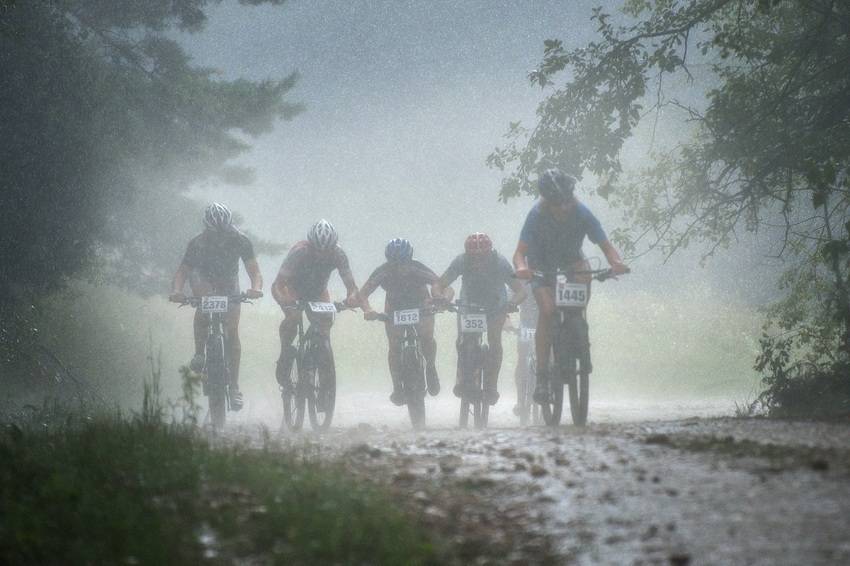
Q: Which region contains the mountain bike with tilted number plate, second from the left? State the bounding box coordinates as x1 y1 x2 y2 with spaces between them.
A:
280 301 352 432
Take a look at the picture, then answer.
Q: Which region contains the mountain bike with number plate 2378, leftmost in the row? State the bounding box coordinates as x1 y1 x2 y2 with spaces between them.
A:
173 294 251 430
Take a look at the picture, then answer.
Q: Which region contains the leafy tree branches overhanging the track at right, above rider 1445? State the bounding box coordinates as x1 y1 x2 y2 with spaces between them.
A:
489 0 850 412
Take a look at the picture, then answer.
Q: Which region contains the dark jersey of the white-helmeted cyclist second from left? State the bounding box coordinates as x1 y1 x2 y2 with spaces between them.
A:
278 240 351 300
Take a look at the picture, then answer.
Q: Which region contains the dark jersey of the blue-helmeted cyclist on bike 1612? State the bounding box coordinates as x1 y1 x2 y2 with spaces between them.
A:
360 260 439 311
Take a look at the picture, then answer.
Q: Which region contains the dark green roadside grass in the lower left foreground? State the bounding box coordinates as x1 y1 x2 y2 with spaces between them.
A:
0 413 444 564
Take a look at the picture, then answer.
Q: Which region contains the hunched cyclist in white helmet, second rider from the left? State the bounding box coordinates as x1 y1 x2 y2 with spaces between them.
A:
272 219 358 383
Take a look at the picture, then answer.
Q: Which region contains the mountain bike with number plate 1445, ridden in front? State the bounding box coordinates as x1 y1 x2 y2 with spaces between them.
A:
534 269 628 426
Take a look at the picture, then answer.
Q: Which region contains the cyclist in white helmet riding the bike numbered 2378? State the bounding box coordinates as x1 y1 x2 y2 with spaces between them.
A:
169 202 263 411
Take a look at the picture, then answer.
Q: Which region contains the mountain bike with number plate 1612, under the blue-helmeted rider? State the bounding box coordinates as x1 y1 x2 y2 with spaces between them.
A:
366 306 442 430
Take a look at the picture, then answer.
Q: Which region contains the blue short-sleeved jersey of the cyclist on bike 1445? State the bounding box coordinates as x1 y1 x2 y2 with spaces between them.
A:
519 201 608 271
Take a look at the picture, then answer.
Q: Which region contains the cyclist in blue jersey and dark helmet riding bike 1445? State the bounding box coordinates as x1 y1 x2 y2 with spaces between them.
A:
506 169 628 403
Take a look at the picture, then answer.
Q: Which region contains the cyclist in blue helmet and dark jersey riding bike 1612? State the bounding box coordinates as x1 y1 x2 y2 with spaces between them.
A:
360 242 450 405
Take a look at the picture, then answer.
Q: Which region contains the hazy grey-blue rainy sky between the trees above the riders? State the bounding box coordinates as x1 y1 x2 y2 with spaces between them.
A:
182 0 776 306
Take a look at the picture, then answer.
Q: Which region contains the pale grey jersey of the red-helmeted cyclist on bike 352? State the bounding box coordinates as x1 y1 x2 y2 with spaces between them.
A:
441 250 514 310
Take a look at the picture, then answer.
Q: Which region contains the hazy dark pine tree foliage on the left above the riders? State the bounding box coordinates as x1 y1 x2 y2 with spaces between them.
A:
0 0 300 303
